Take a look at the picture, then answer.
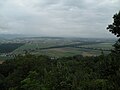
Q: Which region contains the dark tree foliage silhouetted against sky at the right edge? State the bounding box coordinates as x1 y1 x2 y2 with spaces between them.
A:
107 11 120 54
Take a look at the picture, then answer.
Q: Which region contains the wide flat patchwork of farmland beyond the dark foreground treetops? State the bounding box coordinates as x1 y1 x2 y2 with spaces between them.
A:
0 38 115 59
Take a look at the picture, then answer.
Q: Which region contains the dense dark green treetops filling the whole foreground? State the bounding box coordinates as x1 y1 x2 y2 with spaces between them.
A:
0 53 120 90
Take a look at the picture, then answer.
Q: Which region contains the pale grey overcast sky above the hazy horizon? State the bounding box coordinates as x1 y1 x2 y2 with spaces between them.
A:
0 0 120 38
